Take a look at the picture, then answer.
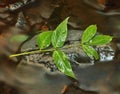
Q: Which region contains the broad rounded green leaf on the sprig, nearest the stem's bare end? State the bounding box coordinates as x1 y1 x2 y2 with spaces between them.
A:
37 31 53 49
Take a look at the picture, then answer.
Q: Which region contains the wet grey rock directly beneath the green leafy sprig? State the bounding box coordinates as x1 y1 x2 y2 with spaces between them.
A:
20 30 116 67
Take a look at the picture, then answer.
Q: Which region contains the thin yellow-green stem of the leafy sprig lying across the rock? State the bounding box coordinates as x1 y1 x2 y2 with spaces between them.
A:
9 43 81 58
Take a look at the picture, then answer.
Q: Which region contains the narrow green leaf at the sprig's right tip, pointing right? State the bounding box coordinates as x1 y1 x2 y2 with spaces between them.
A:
88 35 112 45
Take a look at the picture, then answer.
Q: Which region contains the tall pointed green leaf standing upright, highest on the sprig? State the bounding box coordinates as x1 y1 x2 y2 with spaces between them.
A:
52 17 69 48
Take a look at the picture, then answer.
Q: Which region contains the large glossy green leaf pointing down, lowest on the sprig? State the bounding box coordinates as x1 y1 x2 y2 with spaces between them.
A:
53 50 76 79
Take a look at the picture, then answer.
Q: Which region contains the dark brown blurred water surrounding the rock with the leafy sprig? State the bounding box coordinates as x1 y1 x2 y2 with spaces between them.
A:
0 0 120 94
